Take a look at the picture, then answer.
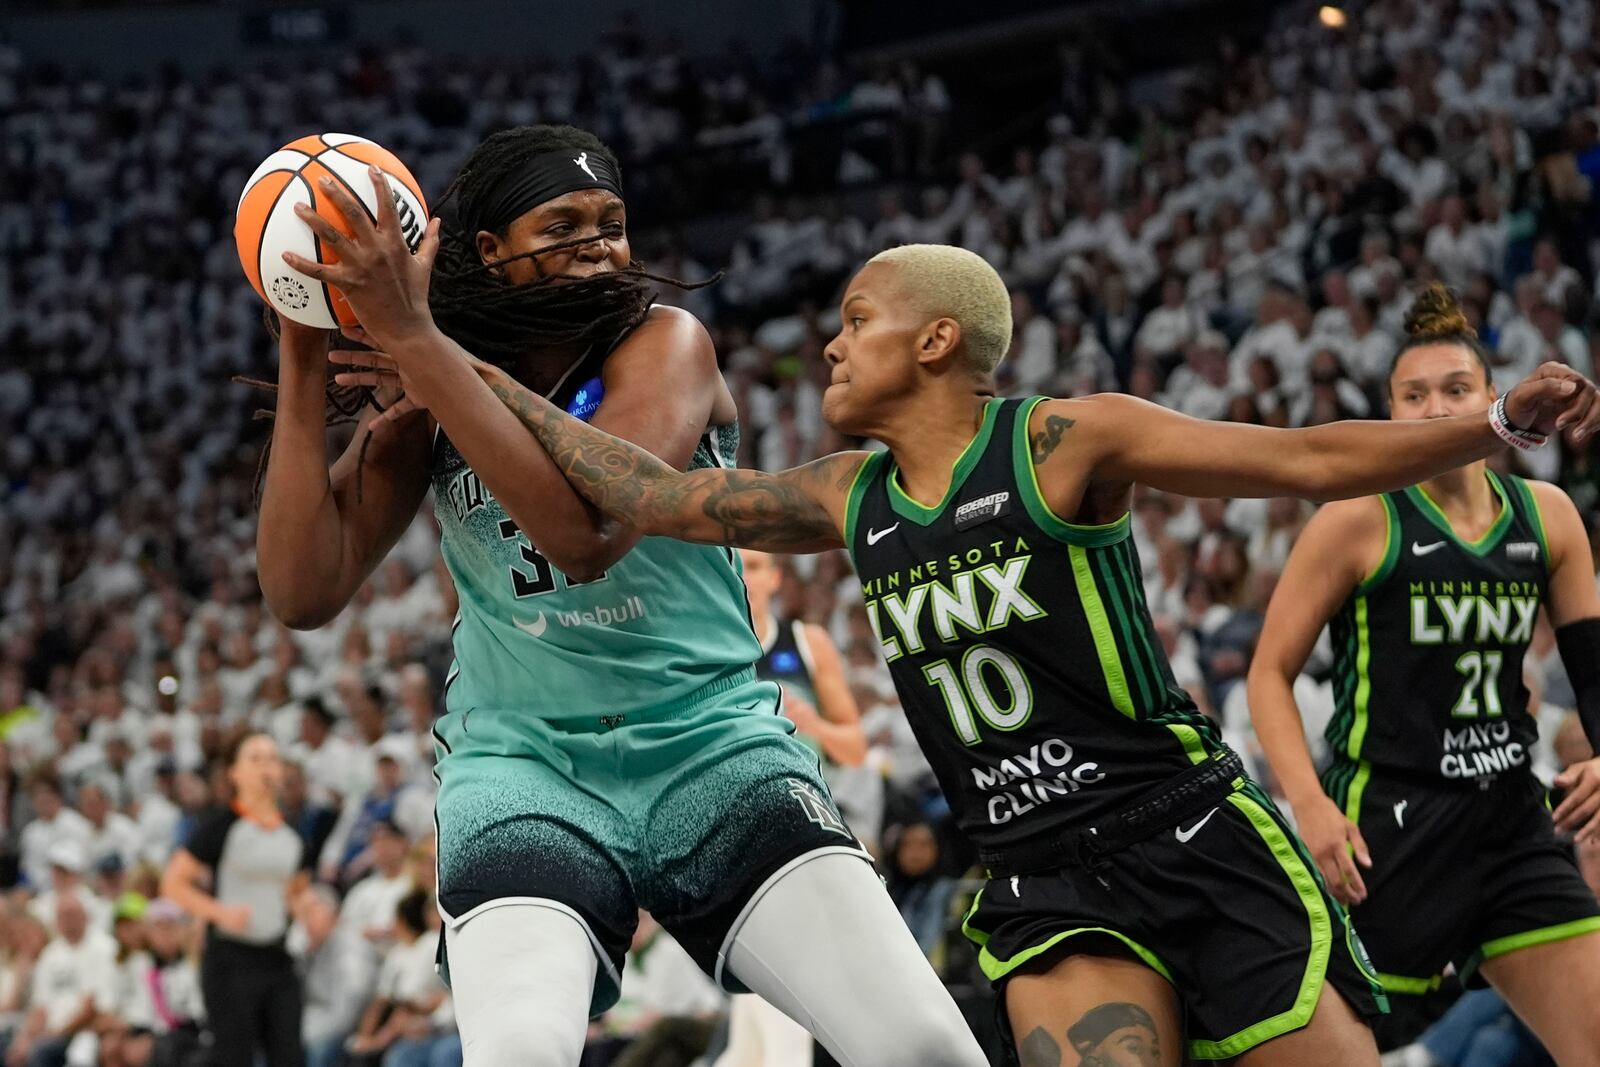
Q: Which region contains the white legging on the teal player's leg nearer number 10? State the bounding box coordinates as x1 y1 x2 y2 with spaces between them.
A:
723 853 989 1067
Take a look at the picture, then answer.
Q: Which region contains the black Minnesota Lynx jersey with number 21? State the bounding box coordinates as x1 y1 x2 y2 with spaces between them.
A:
1326 472 1549 805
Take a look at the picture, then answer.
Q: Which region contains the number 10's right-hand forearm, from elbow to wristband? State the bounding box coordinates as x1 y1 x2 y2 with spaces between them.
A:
1285 414 1506 501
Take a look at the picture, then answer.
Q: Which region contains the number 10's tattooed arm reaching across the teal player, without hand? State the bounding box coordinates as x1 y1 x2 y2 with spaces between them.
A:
493 382 859 552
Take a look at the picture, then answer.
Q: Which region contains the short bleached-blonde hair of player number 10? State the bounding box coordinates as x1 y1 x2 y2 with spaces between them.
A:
867 245 1011 374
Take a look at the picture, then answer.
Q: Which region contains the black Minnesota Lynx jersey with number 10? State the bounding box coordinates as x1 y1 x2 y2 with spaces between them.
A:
845 397 1222 846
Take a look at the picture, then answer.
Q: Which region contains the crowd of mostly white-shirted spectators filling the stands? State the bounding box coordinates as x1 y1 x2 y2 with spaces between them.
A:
0 0 1600 1067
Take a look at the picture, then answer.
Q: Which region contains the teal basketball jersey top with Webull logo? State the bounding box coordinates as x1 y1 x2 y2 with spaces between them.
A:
432 340 762 718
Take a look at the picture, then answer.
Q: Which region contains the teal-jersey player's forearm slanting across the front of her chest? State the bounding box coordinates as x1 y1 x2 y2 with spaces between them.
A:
390 333 633 579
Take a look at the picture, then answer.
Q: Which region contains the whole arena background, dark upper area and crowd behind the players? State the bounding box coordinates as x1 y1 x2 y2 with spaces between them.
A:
0 0 1600 1067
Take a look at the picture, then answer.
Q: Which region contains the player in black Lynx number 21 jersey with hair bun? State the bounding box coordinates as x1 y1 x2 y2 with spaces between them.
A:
1250 285 1600 1065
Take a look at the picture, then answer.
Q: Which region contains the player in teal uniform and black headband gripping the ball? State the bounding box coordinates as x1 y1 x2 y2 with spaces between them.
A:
258 126 982 1067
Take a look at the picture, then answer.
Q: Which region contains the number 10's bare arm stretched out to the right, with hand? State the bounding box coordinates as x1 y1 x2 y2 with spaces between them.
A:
1049 363 1600 510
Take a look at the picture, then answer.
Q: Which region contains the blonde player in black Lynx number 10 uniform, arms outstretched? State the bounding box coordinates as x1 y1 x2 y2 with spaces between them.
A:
341 245 1600 1067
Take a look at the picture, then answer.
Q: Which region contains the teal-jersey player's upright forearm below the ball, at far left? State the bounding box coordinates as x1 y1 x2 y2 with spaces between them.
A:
256 360 344 625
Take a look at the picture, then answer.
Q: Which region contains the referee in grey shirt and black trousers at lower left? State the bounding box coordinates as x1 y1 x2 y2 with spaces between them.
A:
162 733 310 1067
